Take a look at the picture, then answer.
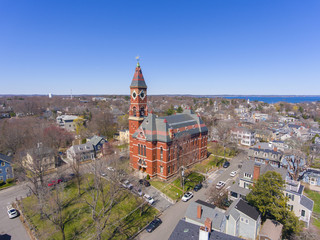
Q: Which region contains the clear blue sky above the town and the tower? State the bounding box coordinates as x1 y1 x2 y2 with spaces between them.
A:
0 0 320 95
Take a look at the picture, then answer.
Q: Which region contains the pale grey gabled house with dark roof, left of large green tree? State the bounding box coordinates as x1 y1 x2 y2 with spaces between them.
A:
225 198 261 240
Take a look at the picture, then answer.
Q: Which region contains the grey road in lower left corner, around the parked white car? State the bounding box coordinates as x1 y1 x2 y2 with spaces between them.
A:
0 184 30 240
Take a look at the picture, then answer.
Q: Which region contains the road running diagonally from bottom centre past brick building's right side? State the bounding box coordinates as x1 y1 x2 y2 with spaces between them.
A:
136 153 246 240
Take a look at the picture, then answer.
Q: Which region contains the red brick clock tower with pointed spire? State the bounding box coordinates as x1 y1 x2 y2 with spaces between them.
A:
129 60 148 158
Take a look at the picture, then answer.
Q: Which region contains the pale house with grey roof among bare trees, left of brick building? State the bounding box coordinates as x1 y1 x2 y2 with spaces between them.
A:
67 142 96 162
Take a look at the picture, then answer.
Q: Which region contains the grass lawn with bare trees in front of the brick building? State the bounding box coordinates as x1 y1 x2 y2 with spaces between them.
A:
22 174 158 240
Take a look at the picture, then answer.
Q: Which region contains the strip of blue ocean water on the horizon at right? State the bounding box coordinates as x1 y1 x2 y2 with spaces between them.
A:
223 96 320 103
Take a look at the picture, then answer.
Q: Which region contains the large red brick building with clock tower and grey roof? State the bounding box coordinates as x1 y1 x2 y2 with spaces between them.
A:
129 63 208 179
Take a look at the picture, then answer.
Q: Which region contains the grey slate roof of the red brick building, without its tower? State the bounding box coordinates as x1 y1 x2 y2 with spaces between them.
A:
132 110 208 142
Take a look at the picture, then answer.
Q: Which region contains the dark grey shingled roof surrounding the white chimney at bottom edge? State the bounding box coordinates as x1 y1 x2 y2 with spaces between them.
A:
169 220 241 240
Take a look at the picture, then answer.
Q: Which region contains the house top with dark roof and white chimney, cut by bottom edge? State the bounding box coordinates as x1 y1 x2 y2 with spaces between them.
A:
169 219 241 240
